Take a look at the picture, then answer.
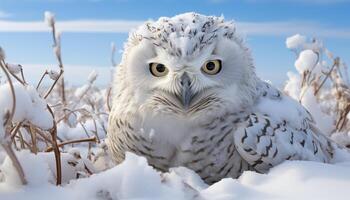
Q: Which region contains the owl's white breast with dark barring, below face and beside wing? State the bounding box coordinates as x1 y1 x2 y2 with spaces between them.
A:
108 112 249 183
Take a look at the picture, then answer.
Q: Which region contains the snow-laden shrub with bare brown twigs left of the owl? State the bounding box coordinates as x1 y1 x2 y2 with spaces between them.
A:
0 12 112 184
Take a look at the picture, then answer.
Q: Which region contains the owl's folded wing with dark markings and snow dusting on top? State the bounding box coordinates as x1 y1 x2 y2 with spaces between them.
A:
234 82 334 172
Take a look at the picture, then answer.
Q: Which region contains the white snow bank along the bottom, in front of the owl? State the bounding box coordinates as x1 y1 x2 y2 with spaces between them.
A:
0 152 350 200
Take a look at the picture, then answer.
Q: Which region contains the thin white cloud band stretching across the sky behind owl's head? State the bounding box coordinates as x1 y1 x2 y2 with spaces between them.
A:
0 20 350 38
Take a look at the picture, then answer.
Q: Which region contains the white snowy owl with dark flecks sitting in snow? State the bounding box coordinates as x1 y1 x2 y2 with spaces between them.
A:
107 13 336 183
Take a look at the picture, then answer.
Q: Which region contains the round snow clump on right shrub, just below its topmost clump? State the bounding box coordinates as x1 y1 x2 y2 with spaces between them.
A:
295 50 318 74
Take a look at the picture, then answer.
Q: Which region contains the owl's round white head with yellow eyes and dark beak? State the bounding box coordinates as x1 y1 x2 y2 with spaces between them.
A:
113 13 256 119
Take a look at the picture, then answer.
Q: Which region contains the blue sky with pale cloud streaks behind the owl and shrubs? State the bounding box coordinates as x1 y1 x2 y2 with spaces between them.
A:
0 0 350 86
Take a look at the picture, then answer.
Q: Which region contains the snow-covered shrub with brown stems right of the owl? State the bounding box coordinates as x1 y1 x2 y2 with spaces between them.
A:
284 34 350 145
